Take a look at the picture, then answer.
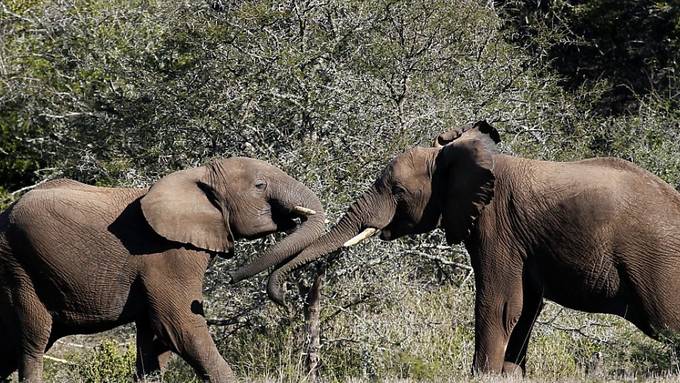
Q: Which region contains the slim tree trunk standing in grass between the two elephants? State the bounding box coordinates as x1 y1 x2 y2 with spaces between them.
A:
305 268 324 383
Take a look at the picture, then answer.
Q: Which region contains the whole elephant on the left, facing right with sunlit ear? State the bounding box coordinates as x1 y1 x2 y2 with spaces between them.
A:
0 158 324 382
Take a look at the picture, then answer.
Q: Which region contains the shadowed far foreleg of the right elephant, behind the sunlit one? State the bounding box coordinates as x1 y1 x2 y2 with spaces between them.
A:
503 287 543 374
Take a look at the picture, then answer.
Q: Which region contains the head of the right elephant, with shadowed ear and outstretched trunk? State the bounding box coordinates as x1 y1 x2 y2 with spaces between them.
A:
267 121 500 304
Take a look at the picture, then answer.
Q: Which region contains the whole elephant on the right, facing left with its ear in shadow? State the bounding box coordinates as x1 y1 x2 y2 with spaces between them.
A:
268 122 680 373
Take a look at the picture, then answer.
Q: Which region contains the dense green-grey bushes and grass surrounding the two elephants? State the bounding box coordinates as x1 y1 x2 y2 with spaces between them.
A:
0 0 680 382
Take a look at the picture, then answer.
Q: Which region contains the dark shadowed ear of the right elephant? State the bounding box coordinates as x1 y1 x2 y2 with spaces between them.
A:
437 137 495 244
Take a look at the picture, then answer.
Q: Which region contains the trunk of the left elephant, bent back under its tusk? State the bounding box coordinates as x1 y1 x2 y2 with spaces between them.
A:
228 177 326 283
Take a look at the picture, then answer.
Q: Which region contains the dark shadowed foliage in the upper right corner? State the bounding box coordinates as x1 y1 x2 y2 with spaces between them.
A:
497 0 680 115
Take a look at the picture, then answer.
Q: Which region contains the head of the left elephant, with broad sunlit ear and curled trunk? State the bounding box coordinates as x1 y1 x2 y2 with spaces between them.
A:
140 157 325 274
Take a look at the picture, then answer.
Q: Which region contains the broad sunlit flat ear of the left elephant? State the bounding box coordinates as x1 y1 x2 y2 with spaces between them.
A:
141 167 234 252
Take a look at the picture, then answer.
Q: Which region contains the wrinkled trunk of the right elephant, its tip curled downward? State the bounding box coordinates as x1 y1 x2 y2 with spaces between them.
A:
267 187 395 306
